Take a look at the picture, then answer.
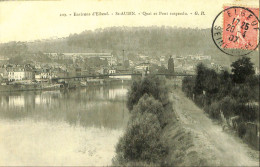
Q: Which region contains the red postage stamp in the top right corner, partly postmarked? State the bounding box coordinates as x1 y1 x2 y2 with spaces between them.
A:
222 6 259 50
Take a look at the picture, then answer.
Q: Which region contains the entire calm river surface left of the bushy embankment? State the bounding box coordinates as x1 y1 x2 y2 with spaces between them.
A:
0 85 129 166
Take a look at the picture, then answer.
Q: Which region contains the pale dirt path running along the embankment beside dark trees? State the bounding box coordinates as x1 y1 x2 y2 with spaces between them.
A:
171 89 259 166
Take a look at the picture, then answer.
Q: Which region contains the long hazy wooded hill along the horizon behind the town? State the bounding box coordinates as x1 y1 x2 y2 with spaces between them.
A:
0 26 259 63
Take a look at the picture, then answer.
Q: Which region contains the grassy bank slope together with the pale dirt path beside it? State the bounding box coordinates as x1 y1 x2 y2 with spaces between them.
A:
163 89 259 166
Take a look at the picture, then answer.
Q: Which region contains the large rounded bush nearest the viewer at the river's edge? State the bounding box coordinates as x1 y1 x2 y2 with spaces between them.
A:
115 113 167 165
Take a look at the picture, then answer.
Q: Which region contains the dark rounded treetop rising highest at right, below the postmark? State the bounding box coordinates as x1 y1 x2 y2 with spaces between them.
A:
231 57 255 84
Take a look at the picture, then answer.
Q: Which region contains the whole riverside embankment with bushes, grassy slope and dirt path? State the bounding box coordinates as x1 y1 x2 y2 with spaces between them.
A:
114 78 259 166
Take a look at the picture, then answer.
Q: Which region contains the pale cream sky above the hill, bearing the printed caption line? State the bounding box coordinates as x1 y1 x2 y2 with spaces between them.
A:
0 0 259 43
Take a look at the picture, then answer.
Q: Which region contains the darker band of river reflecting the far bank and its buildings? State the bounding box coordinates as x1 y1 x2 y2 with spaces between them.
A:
0 85 128 129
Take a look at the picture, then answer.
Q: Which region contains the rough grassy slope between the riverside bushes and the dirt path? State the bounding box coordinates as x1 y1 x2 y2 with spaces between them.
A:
162 100 210 166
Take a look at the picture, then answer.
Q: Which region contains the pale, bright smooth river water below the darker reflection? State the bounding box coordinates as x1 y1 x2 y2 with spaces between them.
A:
0 119 123 166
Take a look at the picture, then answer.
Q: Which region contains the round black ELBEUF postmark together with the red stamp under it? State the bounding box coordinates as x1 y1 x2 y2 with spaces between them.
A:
211 6 260 56
